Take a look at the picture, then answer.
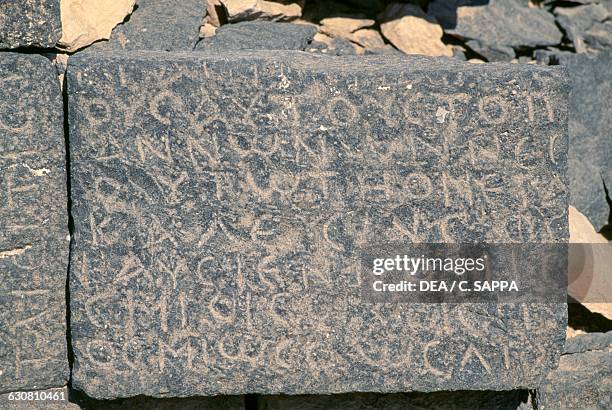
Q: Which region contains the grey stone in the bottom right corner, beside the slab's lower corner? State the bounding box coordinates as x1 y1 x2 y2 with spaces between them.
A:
537 333 612 410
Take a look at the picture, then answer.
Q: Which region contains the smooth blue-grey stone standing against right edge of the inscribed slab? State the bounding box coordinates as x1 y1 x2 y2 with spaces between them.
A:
556 53 612 230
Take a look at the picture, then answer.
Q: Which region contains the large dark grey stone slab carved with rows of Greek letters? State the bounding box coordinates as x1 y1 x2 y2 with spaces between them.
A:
67 51 569 398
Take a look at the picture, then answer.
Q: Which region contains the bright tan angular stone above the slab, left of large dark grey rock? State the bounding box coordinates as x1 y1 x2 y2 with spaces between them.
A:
380 4 453 57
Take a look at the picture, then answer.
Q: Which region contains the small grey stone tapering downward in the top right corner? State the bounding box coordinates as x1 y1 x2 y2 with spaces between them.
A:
555 4 608 53
